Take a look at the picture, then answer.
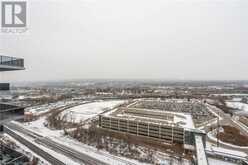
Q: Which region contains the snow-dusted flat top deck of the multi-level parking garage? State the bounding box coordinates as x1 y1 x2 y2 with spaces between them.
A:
102 108 195 129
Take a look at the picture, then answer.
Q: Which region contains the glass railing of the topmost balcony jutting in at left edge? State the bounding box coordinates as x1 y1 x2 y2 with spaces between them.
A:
0 55 24 68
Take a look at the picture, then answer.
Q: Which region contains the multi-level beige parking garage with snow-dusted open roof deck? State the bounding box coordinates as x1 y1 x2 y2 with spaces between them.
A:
99 100 204 149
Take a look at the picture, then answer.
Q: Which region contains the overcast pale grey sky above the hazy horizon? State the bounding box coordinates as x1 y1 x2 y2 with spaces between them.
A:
0 0 248 81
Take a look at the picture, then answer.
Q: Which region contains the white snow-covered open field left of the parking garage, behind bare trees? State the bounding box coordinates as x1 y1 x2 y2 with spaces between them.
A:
61 100 125 123
